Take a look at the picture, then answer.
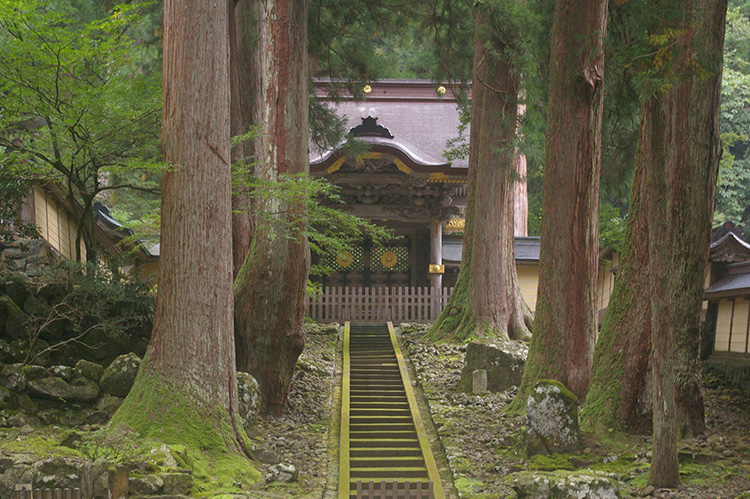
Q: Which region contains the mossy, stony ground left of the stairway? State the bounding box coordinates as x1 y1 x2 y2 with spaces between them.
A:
0 327 338 499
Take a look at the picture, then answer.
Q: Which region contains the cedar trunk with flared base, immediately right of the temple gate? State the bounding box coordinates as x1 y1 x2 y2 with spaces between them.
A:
432 0 532 340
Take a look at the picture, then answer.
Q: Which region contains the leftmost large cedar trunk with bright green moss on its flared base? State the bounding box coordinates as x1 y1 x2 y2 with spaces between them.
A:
112 0 250 453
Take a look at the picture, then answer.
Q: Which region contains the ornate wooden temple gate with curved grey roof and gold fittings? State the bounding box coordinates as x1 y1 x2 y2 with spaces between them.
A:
308 80 616 321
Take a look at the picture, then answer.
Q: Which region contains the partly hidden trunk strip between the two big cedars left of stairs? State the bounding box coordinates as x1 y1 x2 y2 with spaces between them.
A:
228 0 263 277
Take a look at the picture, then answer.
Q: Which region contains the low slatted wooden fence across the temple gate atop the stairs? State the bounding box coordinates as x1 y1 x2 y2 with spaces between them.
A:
306 286 453 323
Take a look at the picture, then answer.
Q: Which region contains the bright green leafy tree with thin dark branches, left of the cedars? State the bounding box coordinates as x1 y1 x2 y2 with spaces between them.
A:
0 0 159 258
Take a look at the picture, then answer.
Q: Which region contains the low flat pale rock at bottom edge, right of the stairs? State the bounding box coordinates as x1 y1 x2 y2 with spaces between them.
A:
511 471 624 499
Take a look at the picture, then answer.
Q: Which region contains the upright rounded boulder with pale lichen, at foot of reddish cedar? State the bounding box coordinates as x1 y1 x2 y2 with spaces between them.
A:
526 380 581 456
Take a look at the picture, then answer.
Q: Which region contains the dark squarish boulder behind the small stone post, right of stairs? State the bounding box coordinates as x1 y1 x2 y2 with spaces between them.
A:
458 340 529 393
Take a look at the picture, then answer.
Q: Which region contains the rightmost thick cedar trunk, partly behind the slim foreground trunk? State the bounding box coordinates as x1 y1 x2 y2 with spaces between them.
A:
668 0 727 436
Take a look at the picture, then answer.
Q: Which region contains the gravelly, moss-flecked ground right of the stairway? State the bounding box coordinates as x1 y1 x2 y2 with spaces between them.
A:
403 329 750 499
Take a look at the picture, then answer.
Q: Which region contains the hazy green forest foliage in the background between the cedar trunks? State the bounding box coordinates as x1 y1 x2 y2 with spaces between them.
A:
0 0 750 249
